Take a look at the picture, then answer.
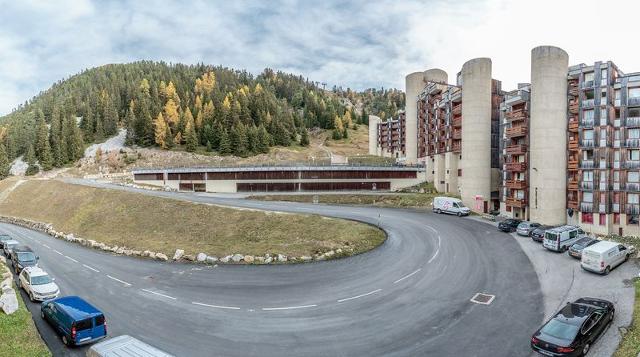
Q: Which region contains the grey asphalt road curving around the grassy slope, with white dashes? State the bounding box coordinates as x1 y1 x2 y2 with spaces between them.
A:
5 182 544 356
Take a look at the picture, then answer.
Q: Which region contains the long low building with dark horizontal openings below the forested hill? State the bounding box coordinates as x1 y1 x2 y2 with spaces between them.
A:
133 166 426 192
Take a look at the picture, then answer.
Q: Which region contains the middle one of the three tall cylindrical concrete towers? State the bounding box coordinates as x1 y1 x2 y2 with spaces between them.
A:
459 58 491 212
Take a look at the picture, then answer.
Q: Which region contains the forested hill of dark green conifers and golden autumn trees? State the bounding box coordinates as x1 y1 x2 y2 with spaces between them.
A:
0 61 404 175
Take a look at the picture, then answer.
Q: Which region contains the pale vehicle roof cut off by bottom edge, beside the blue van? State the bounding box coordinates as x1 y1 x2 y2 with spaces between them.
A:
87 335 173 357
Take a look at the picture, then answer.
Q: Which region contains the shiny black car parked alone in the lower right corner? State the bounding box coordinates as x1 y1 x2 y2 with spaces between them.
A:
531 298 615 356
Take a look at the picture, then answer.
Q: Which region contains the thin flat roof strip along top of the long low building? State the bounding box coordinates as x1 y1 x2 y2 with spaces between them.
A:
131 165 424 174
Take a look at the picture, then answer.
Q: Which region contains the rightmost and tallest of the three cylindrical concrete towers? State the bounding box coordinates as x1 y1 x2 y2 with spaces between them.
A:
529 46 569 225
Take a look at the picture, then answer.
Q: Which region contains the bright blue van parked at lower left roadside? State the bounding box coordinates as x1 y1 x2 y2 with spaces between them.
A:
40 296 107 346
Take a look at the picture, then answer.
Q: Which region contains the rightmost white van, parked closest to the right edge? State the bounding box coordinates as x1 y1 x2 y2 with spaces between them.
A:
580 240 633 275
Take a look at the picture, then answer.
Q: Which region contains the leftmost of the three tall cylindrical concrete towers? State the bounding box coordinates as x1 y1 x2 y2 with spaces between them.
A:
405 72 425 164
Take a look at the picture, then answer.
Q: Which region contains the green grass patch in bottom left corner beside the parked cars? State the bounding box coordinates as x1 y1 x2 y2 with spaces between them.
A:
0 264 51 357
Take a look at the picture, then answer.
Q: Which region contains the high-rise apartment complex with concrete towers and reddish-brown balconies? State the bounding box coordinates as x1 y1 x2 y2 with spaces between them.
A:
369 46 640 234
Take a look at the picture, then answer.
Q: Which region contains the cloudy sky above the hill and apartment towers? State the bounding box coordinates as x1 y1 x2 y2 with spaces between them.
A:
0 0 640 114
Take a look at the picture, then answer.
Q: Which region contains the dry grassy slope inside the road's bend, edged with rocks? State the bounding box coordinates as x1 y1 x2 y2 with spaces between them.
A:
0 181 385 256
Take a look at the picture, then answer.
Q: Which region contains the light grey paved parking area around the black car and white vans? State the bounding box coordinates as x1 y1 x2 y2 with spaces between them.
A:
476 217 640 356
